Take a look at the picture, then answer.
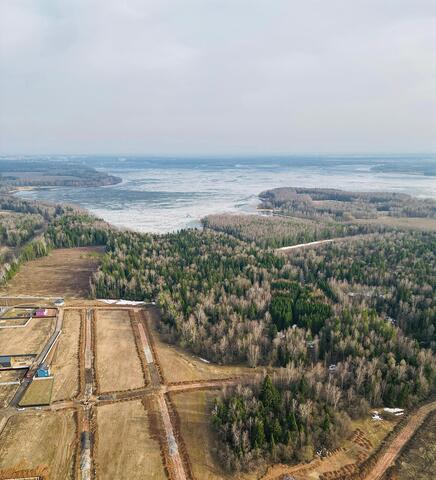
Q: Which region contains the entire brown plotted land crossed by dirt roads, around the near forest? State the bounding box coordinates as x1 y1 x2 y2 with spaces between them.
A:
0 249 436 480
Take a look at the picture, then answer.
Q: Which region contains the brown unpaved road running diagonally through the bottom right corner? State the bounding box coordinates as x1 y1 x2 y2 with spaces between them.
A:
365 401 436 480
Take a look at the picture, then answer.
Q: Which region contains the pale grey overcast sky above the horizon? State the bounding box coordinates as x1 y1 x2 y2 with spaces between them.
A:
0 0 436 154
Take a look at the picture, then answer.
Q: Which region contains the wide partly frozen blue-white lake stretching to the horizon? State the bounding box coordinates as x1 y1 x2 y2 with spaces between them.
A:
15 155 436 232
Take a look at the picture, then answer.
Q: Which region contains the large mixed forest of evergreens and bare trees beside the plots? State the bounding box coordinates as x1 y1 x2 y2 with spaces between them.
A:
1 186 436 471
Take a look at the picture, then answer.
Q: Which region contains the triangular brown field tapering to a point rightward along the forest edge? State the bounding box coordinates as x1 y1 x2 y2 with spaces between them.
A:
146 309 255 383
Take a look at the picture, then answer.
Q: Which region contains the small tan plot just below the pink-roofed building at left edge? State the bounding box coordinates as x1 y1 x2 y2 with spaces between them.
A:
0 318 55 355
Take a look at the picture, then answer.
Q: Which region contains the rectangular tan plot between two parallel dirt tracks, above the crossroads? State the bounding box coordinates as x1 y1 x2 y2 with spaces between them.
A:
95 310 144 392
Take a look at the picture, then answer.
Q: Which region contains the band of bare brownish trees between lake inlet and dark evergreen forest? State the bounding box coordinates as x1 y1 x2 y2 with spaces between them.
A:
202 214 389 248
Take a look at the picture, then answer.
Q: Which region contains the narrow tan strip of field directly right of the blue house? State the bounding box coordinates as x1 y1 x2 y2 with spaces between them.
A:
51 310 81 401
